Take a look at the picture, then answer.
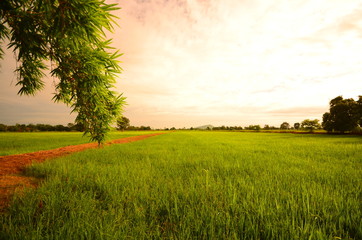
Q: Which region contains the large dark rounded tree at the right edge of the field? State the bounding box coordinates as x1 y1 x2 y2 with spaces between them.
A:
322 96 362 133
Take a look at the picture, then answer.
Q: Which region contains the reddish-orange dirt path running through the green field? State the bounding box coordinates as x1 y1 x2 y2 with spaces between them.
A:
0 133 164 211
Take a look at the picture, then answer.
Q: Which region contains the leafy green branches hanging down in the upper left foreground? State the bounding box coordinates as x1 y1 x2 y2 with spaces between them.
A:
0 0 124 143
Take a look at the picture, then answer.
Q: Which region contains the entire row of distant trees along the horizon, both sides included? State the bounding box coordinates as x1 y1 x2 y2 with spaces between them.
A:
0 96 362 133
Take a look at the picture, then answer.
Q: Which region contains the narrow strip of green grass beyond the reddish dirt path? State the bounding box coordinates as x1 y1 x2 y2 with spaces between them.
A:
0 131 160 156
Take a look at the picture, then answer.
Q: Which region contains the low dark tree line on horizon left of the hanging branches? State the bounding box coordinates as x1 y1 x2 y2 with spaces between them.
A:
0 123 84 132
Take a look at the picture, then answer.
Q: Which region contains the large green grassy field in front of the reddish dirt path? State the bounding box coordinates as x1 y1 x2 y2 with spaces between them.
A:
0 132 362 240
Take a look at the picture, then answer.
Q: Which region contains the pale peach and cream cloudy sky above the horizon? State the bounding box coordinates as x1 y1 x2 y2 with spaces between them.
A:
0 0 362 128
